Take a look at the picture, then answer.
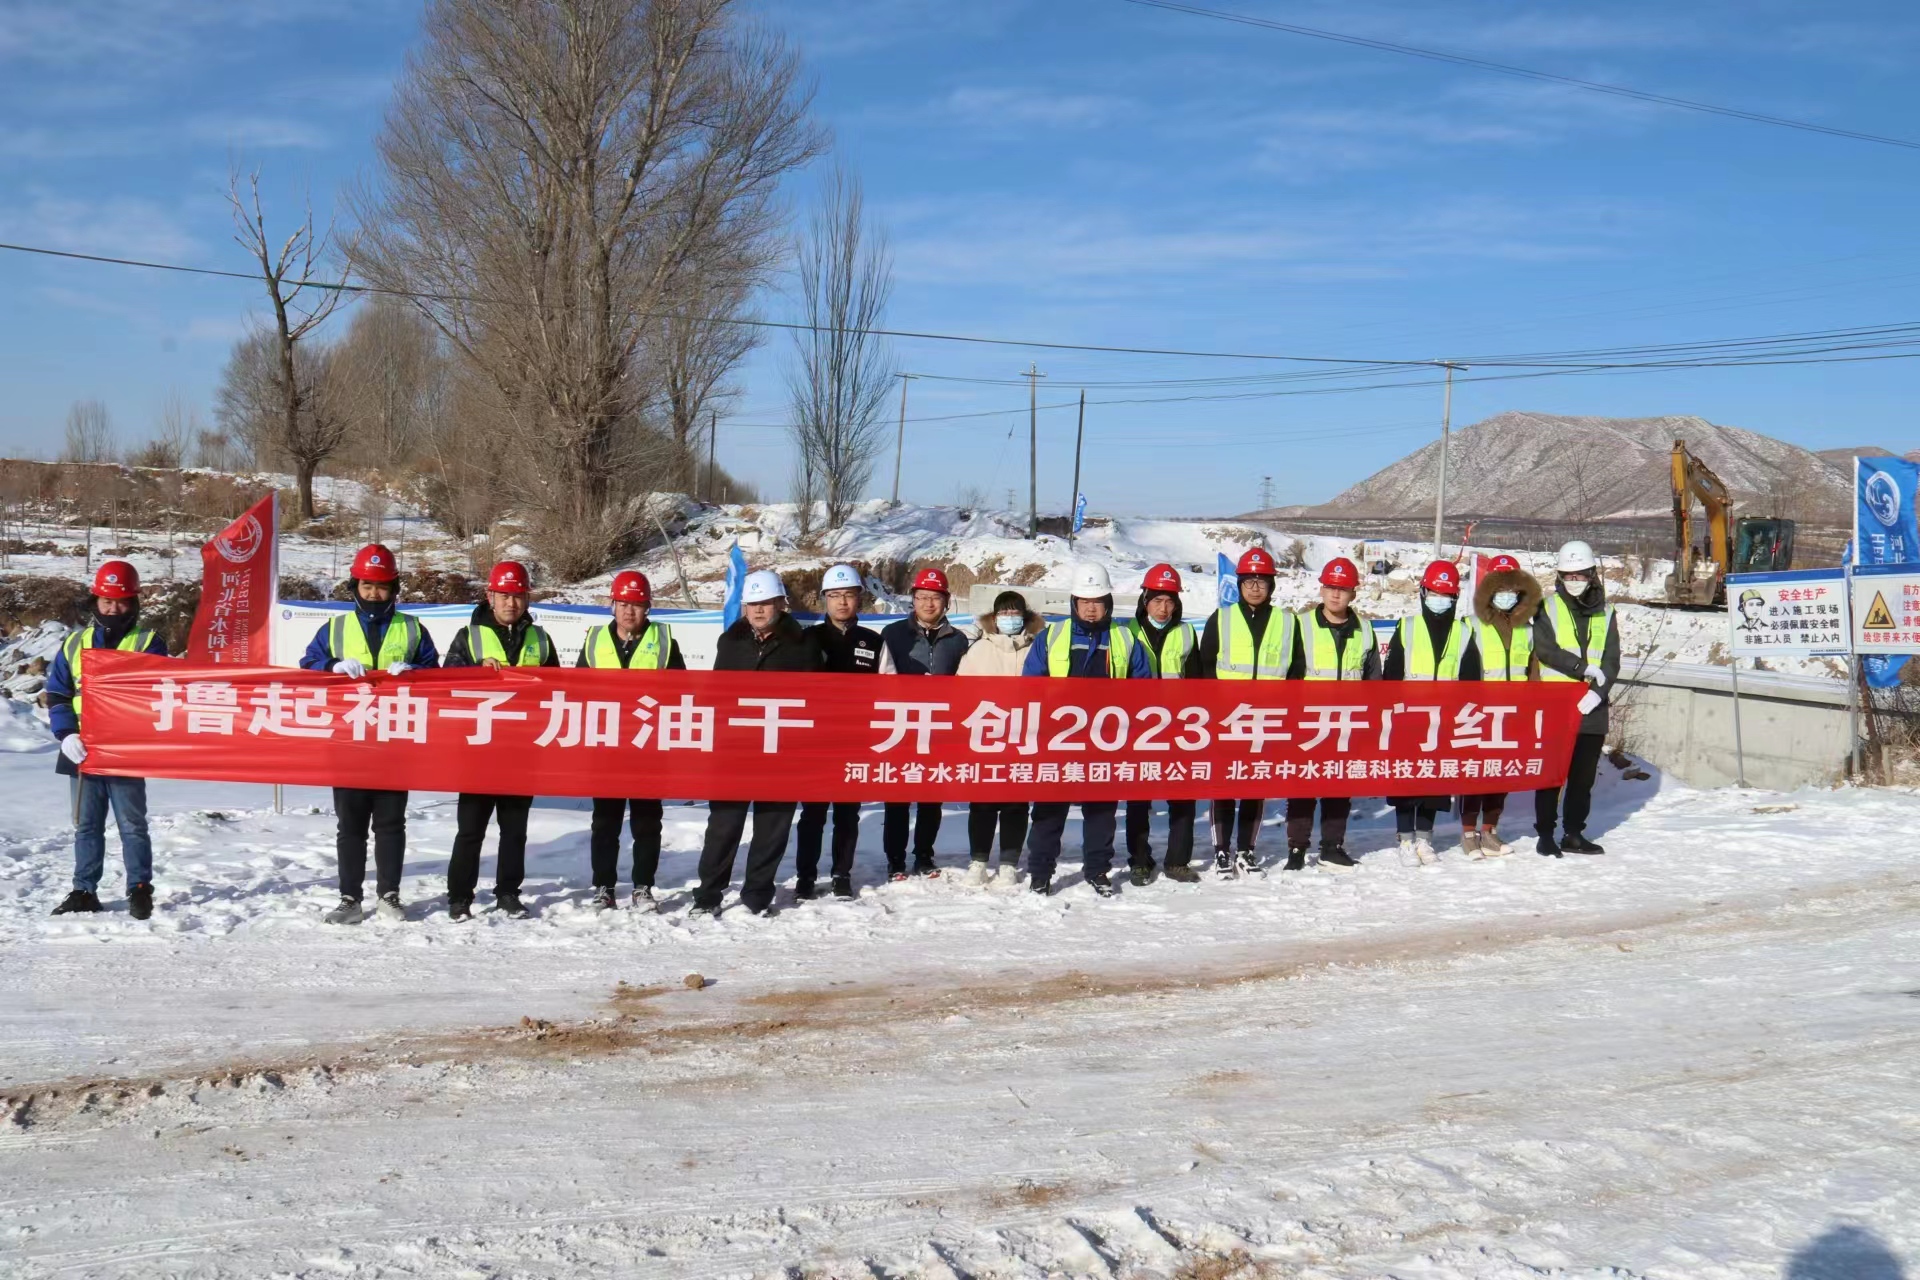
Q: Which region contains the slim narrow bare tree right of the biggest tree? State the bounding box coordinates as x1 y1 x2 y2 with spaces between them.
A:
787 169 895 530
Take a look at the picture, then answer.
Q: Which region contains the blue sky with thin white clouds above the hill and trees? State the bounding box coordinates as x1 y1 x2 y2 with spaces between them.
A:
0 0 1920 514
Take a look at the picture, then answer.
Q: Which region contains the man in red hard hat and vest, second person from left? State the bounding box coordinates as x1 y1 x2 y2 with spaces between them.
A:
300 543 440 925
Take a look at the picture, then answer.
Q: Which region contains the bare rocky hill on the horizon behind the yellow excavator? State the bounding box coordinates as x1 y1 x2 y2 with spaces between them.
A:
1288 411 1853 520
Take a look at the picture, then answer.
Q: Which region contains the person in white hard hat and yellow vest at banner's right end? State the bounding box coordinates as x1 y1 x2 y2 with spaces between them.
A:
1534 541 1620 858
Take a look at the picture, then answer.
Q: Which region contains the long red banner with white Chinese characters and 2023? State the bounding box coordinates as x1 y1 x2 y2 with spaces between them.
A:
83 652 1584 800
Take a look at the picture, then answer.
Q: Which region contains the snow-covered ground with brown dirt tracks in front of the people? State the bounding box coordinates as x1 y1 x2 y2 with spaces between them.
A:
0 723 1920 1280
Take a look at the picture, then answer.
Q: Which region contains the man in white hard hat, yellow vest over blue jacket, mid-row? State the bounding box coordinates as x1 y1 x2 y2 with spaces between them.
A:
1021 564 1154 898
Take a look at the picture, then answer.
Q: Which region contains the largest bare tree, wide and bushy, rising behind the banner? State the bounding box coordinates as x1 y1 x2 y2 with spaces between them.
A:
353 0 820 572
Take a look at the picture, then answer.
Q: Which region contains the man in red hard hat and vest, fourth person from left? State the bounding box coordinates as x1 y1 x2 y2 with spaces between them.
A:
580 568 687 912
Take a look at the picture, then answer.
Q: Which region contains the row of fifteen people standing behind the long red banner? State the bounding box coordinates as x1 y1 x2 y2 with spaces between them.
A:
46 541 1620 925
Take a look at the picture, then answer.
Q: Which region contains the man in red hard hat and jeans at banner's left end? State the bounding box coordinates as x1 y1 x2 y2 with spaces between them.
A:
46 560 167 919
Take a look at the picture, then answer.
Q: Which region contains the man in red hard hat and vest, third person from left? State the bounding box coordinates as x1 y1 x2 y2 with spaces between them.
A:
442 560 561 919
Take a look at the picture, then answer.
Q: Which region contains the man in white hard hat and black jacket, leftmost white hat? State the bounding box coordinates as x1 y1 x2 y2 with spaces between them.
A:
693 568 820 915
